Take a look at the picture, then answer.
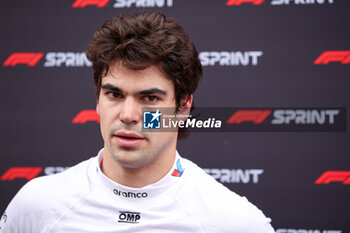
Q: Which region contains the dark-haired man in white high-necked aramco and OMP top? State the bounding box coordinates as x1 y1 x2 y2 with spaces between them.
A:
0 12 274 233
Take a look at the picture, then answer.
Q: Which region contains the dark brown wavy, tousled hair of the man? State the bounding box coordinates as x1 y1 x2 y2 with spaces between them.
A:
86 11 202 136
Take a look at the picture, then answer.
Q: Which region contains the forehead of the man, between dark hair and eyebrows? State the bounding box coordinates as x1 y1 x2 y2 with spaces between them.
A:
102 62 174 90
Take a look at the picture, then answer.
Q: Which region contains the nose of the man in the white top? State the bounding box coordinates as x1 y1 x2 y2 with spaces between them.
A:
119 97 141 124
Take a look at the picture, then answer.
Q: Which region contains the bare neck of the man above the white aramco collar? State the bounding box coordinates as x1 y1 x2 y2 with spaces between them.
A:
101 145 176 188
